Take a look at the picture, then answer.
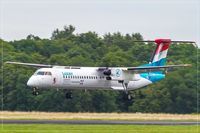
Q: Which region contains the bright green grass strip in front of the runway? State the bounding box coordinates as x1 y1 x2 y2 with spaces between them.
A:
0 124 199 133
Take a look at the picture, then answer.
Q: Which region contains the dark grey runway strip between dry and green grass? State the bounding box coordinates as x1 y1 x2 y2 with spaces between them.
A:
1 120 199 125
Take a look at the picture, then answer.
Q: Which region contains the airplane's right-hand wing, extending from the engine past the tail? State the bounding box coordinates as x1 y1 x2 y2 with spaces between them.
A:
123 64 192 72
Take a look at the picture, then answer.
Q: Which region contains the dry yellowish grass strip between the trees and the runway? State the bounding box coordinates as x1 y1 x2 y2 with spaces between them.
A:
0 111 198 121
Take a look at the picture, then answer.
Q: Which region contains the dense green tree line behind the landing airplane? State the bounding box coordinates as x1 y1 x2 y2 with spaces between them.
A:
0 25 200 113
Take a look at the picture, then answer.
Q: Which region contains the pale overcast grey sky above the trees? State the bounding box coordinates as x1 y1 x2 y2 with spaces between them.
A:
0 0 200 46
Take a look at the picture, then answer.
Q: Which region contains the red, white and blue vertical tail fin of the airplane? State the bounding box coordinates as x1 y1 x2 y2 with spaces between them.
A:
149 39 171 66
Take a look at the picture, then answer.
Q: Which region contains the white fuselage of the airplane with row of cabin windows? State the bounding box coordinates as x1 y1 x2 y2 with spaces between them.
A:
27 66 152 90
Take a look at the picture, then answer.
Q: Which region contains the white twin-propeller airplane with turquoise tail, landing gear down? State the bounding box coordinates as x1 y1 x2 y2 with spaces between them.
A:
6 39 195 99
